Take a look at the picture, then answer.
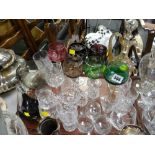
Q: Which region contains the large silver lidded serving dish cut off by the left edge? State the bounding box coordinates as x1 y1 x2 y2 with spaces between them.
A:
0 49 26 94
